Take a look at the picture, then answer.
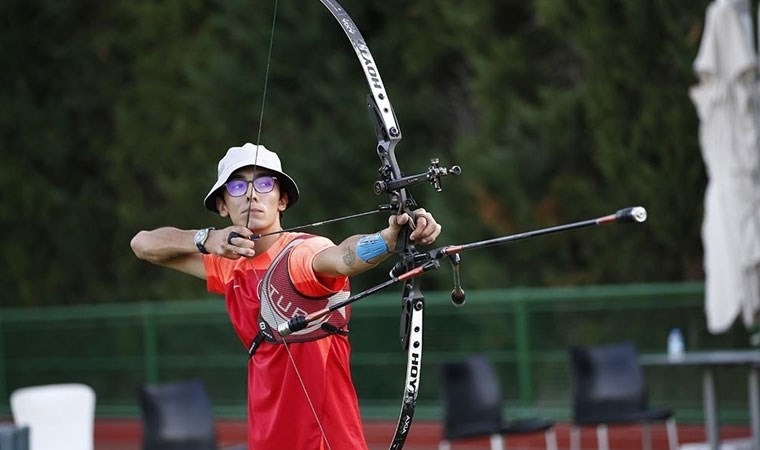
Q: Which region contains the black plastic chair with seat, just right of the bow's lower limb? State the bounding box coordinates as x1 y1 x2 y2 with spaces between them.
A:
438 355 557 450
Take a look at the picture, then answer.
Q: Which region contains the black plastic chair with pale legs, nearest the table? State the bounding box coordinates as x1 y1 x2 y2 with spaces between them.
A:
570 341 678 450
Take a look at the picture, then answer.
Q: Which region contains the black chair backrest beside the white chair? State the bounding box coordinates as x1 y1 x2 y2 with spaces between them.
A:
137 379 216 450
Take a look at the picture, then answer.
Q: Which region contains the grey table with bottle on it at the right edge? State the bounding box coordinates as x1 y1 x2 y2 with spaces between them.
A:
639 350 760 450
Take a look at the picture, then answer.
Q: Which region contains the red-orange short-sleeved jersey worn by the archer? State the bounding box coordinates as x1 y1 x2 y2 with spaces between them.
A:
203 233 367 450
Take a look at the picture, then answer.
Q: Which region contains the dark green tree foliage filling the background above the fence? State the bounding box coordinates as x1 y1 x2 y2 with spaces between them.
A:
0 0 707 305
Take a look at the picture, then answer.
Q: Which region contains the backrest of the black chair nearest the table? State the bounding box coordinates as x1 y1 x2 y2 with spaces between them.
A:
570 341 647 422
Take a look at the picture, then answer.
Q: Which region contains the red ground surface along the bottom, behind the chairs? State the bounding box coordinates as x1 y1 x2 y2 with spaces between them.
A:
90 419 750 450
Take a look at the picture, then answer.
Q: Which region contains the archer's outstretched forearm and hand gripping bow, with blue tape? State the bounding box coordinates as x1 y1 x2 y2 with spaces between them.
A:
312 208 441 277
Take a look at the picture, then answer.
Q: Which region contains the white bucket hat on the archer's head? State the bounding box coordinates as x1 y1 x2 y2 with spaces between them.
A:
203 143 298 213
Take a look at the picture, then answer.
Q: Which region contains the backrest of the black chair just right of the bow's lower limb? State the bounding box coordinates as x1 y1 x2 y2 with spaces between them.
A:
439 355 502 439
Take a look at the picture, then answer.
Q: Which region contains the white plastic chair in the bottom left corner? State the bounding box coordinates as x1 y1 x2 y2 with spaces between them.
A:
10 383 95 450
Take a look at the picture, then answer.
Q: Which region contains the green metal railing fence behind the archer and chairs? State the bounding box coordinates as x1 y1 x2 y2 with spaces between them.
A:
0 283 749 422
